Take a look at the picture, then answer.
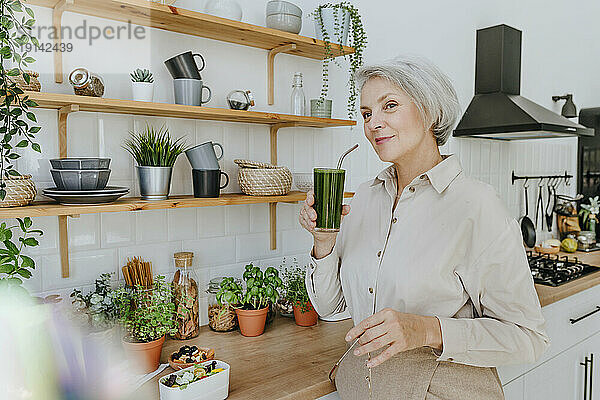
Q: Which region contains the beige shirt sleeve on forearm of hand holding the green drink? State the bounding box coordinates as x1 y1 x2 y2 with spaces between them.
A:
306 245 346 317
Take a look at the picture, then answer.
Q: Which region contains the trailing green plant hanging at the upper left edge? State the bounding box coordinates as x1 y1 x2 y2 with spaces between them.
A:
0 0 41 200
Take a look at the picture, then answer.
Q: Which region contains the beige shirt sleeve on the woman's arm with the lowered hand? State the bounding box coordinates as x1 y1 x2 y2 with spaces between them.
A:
434 219 549 367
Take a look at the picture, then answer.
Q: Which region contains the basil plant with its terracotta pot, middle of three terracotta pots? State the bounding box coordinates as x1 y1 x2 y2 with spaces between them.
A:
217 263 283 337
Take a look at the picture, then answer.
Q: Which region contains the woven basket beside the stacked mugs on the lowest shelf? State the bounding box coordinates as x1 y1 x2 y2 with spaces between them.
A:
233 160 292 196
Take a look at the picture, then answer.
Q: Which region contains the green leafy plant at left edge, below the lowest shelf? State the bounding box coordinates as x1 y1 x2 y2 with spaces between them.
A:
0 217 43 290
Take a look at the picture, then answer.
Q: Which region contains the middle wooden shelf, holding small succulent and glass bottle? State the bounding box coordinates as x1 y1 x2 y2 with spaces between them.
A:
26 92 356 128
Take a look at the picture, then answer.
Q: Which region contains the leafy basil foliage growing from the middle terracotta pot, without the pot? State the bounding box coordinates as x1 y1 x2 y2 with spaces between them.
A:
216 263 283 310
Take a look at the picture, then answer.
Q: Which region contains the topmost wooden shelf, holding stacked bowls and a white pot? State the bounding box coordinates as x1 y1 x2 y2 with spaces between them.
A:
26 0 354 59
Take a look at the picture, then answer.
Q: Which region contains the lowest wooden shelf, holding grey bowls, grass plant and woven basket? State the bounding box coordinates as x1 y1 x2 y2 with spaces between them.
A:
0 191 354 218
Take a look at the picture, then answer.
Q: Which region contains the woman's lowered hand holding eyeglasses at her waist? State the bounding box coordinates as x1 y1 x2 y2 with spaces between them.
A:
346 308 442 367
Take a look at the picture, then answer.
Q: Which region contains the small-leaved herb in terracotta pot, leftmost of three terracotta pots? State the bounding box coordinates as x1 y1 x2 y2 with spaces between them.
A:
116 276 177 373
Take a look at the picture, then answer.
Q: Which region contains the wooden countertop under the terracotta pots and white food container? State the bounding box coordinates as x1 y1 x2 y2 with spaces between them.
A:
144 316 353 400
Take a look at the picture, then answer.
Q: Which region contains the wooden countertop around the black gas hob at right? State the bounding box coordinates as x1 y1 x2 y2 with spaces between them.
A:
535 251 600 307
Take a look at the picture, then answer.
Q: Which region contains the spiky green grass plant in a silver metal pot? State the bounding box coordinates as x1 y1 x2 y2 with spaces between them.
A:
123 125 186 200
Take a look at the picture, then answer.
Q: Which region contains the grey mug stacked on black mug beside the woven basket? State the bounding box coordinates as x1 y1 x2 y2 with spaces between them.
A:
185 142 229 197
